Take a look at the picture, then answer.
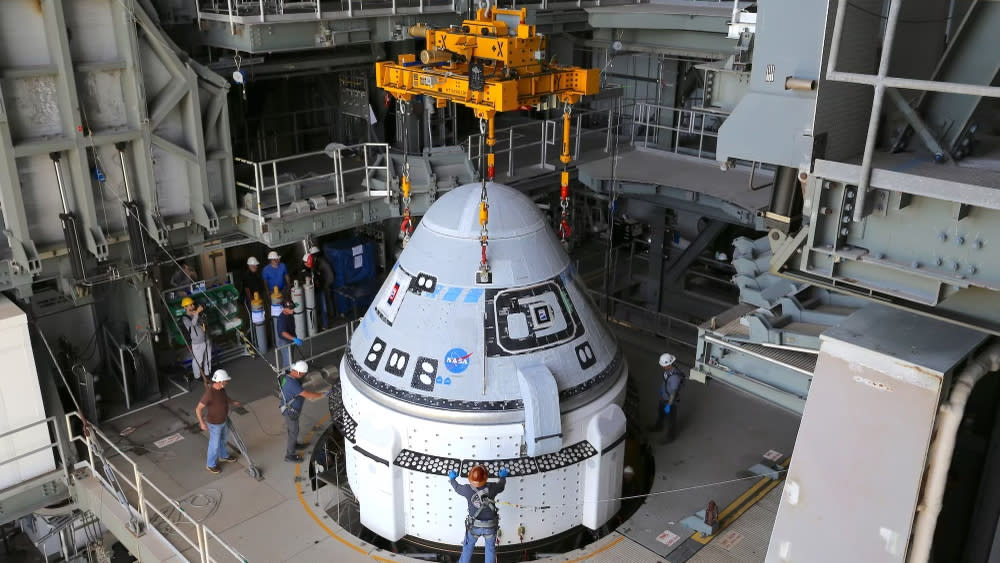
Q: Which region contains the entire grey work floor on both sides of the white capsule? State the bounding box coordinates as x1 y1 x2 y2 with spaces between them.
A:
90 312 799 563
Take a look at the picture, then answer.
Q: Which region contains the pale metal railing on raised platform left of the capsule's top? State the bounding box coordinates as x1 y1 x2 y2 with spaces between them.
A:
233 143 392 223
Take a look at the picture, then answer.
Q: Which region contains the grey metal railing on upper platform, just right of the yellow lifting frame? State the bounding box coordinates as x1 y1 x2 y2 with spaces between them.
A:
631 102 729 158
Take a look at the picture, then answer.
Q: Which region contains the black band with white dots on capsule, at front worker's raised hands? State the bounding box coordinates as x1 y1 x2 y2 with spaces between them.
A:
393 440 597 478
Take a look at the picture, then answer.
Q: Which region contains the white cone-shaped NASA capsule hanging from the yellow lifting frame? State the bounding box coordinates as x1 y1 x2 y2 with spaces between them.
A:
335 183 628 545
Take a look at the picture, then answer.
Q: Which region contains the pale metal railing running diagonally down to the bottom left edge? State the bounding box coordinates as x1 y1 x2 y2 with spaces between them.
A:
66 412 247 563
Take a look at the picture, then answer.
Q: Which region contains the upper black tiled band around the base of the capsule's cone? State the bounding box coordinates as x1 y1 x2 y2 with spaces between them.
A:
344 348 624 411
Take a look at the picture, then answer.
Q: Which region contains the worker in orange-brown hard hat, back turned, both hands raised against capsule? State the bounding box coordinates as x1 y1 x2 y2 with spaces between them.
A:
448 465 508 563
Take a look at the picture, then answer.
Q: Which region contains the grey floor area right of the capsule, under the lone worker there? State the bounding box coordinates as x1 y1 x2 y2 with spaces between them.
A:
618 329 799 563
